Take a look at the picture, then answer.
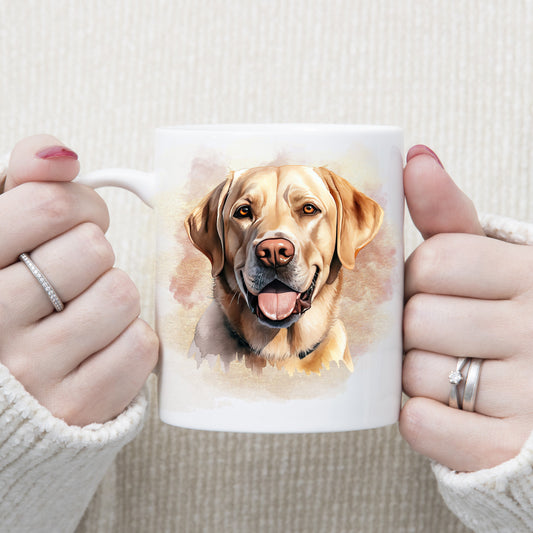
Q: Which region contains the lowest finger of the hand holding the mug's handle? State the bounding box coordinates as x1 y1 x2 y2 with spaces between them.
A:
45 319 159 426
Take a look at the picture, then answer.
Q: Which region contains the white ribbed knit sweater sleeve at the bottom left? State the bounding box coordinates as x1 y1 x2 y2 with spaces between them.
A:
0 364 147 532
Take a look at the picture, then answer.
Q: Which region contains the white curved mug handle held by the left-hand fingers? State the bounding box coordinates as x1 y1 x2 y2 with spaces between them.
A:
74 168 157 208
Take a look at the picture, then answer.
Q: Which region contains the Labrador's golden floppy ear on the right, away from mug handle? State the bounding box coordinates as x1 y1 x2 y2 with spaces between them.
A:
315 167 383 269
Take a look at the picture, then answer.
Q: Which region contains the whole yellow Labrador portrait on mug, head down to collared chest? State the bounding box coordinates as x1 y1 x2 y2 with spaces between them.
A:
185 165 383 374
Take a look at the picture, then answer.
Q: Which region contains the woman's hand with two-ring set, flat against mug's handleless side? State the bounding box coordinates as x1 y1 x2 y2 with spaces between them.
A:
400 146 533 472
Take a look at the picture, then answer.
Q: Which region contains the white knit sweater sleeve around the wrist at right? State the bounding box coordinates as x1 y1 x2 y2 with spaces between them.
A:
432 215 533 533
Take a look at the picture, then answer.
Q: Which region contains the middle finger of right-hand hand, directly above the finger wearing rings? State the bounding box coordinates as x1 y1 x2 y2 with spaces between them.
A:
403 294 520 359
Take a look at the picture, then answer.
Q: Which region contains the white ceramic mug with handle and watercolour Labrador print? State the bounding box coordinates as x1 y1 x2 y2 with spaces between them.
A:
77 124 404 433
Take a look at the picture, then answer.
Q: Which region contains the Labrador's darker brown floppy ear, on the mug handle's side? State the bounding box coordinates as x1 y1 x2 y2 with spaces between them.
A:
185 172 233 277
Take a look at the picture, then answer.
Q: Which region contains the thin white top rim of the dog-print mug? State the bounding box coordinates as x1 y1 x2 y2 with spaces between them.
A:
156 122 403 133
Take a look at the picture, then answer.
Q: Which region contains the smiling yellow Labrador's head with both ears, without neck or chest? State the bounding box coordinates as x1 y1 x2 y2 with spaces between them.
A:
185 165 383 328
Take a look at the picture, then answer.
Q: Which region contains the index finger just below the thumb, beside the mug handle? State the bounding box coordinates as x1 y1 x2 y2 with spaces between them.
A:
0 183 109 268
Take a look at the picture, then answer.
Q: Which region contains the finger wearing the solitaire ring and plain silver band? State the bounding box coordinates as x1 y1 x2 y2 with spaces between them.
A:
402 350 533 418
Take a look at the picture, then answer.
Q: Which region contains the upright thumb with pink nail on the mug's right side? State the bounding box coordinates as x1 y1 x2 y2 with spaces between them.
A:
403 144 484 239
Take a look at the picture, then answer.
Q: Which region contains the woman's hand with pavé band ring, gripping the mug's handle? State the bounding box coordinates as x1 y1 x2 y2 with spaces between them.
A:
0 135 158 426
